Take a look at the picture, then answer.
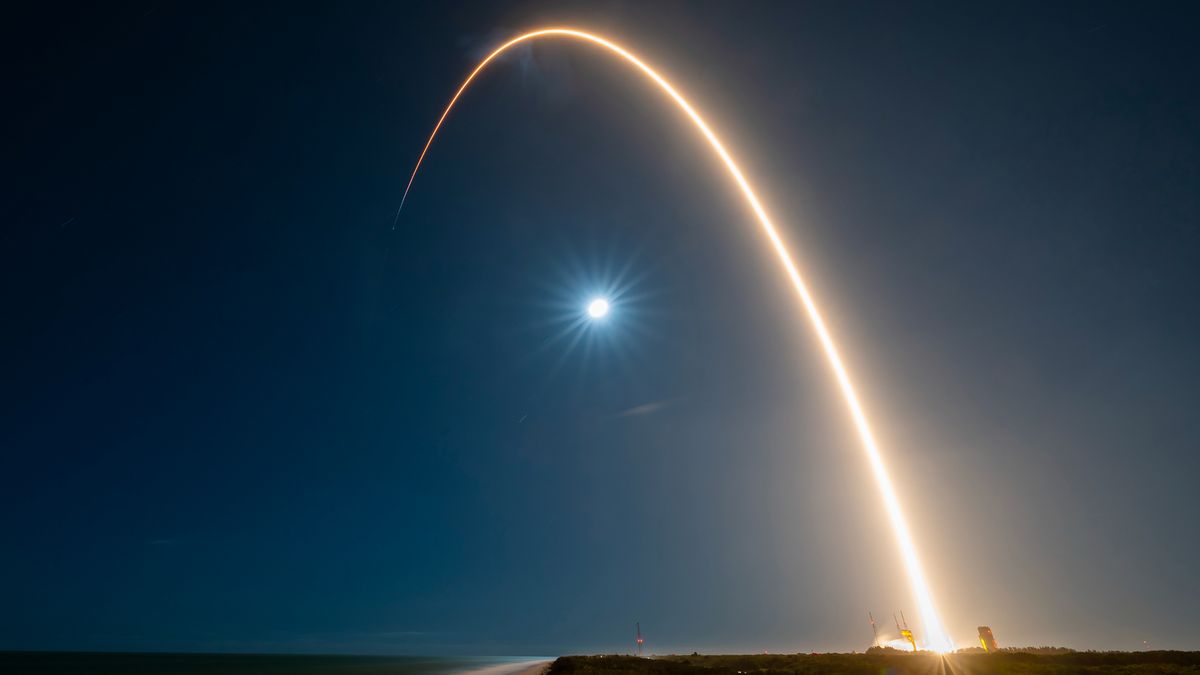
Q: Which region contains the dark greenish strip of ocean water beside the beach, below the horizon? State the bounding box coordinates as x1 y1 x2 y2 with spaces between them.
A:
0 652 552 675
